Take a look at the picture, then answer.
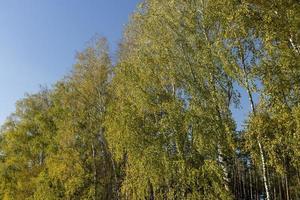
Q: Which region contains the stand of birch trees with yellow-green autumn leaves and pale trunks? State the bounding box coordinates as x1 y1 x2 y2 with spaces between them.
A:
0 0 300 200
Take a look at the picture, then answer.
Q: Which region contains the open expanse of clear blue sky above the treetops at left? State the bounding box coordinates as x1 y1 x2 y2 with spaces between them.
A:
0 0 140 125
